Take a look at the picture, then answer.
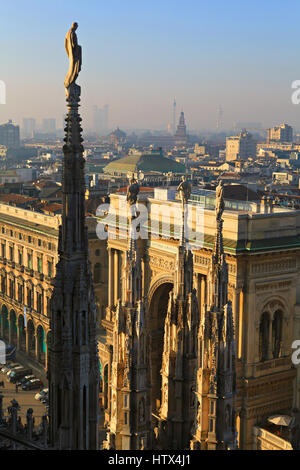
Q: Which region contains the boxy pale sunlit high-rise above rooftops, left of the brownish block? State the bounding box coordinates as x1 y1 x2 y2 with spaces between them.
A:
226 129 256 162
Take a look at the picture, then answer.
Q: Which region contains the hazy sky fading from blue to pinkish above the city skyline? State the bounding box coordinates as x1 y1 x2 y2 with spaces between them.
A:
0 0 300 129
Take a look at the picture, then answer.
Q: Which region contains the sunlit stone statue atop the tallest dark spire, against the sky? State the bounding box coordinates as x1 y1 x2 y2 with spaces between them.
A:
65 23 82 90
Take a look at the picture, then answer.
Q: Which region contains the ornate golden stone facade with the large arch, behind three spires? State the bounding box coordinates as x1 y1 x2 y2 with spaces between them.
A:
100 186 300 449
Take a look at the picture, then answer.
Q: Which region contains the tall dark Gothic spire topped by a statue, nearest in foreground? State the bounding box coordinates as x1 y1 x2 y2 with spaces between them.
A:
48 23 99 450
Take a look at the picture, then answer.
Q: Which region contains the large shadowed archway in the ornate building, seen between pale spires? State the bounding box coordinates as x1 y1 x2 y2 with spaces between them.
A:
149 282 173 412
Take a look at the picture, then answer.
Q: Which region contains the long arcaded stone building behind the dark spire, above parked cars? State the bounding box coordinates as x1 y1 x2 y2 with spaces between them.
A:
0 204 108 370
